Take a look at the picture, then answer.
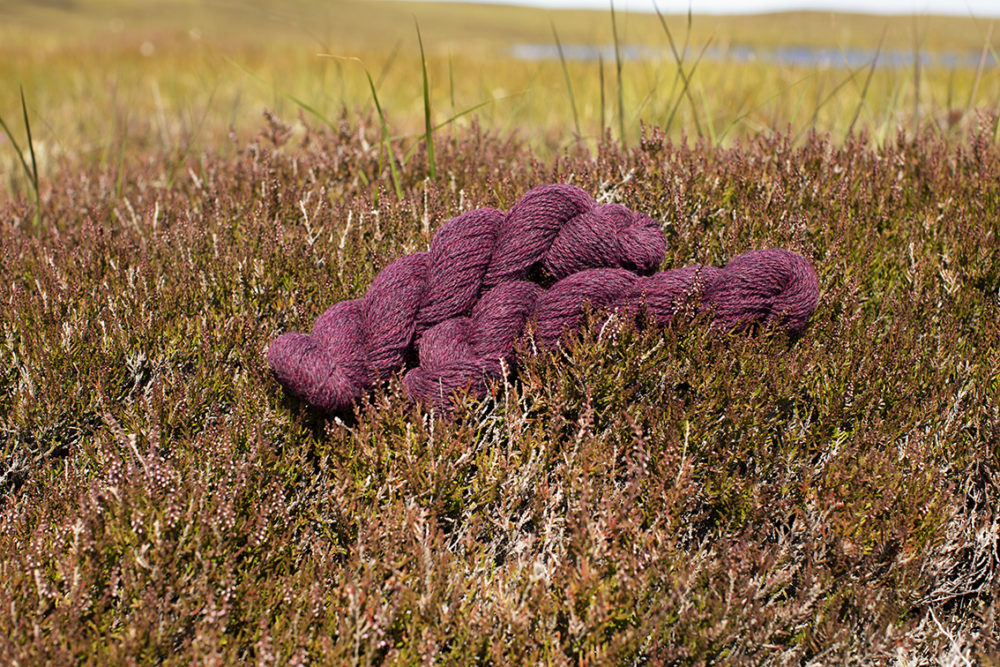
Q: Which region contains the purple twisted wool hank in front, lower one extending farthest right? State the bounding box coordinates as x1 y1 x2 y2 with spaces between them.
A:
403 250 819 411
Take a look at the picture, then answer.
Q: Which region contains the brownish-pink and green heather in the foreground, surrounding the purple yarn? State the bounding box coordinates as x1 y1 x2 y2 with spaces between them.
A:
0 109 1000 664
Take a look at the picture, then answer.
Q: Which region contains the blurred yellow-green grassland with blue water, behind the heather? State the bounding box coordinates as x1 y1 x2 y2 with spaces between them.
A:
0 0 1000 197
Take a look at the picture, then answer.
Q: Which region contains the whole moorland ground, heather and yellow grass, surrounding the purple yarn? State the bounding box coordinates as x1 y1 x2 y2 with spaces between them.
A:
0 1 1000 664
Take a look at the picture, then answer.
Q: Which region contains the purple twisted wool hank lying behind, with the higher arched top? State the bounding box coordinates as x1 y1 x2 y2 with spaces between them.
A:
267 184 666 412
